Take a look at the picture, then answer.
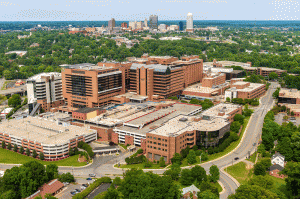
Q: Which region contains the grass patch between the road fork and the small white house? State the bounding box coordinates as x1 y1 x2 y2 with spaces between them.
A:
225 162 253 185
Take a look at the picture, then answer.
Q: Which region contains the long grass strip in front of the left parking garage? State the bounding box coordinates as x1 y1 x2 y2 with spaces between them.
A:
0 148 86 167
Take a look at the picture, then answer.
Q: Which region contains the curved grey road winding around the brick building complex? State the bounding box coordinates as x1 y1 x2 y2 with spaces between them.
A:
0 83 278 199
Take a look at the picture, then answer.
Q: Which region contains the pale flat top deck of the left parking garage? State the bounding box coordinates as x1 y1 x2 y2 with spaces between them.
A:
0 116 95 145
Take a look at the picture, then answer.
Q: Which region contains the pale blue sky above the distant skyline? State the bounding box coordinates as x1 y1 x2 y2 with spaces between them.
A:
0 0 300 21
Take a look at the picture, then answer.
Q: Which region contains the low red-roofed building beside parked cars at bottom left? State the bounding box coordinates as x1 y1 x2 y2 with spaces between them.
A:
26 179 64 199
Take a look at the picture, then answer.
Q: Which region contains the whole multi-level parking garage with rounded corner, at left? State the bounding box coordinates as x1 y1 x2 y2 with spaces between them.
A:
0 116 97 160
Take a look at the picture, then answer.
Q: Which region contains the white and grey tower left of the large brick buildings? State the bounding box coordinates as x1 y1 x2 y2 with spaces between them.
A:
27 72 64 113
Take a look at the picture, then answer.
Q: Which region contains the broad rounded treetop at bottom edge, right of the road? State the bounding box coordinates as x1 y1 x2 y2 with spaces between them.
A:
228 185 279 199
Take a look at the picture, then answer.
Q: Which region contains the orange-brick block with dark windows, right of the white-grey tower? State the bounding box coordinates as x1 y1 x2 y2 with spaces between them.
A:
62 64 126 108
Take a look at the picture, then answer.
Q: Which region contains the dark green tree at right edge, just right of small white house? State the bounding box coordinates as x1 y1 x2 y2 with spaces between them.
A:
282 162 300 198
